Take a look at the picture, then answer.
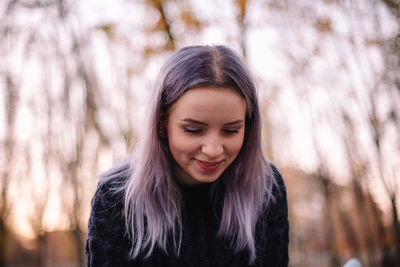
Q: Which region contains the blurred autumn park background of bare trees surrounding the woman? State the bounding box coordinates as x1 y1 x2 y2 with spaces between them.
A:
0 0 400 267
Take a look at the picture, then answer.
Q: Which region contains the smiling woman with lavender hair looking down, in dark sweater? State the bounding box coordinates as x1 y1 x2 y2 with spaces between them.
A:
86 46 289 267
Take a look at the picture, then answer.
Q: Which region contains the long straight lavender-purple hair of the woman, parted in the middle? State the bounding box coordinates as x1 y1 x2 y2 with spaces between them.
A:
101 46 275 262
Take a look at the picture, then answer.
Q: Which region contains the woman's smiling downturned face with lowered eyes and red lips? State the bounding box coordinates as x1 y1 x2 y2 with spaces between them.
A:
165 87 246 185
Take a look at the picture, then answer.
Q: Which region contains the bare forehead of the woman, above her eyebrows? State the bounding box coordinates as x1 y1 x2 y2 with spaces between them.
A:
168 87 246 120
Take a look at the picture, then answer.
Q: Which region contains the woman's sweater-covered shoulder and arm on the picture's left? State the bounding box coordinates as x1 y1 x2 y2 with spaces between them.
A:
85 157 130 266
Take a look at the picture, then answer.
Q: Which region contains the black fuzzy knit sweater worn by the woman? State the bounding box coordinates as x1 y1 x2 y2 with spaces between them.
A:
86 167 289 267
